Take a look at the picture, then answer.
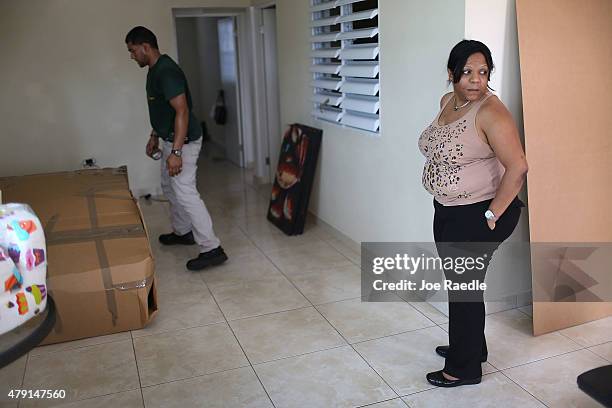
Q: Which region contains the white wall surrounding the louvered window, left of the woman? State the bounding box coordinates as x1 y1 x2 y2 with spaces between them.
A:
277 0 465 242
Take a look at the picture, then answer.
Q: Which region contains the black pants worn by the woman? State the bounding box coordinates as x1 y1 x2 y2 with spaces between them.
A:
433 198 524 379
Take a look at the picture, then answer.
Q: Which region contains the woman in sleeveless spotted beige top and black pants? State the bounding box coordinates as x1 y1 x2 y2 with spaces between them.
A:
419 40 527 387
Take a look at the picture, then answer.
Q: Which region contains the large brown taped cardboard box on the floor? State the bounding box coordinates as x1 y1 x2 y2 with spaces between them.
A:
0 167 157 344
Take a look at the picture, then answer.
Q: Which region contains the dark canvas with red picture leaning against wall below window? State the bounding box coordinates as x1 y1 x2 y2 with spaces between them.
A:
268 124 323 235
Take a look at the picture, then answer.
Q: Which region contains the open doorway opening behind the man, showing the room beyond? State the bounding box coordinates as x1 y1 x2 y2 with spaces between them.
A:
174 9 247 168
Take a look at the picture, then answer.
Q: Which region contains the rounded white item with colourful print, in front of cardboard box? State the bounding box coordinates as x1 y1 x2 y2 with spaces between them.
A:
0 204 47 334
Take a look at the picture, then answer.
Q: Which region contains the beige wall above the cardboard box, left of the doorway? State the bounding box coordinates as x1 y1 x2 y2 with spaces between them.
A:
0 0 250 195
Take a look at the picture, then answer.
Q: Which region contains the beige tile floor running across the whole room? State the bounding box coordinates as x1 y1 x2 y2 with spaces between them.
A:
0 150 612 408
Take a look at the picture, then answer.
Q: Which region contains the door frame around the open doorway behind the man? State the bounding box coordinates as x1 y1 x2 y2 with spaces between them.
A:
172 7 256 168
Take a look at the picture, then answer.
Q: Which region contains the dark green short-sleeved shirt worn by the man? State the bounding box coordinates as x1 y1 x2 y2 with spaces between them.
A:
147 54 202 142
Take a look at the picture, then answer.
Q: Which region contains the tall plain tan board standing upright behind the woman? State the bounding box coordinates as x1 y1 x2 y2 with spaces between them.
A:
517 0 612 334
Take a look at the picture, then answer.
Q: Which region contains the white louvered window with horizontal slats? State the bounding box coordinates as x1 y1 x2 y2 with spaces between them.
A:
310 0 380 133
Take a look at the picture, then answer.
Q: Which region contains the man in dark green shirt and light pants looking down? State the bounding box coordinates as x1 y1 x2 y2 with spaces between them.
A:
125 26 227 271
